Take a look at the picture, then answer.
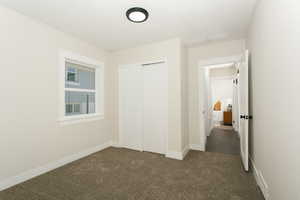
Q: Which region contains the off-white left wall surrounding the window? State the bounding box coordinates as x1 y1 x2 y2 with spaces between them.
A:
0 4 113 181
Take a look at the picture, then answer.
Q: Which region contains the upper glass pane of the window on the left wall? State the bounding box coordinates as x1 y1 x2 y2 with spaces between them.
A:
65 62 95 90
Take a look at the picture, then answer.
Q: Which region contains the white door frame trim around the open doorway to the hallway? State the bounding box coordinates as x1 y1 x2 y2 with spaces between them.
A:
197 54 243 151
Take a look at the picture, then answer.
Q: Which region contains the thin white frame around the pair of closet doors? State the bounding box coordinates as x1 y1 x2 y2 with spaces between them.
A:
117 58 170 155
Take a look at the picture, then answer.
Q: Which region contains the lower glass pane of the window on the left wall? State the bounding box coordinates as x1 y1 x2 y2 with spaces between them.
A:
65 91 96 116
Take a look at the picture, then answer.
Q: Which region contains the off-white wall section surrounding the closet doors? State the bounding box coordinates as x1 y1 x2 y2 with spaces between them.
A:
112 39 183 152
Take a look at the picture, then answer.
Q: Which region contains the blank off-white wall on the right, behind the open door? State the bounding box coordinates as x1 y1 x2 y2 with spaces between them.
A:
248 0 300 200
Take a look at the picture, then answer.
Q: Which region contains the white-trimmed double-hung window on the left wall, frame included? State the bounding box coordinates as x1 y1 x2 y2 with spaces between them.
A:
60 52 103 121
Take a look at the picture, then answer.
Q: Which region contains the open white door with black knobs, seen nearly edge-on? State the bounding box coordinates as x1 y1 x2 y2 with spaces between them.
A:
239 51 250 171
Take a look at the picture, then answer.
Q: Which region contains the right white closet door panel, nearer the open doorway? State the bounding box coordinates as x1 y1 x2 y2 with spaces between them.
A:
142 63 168 154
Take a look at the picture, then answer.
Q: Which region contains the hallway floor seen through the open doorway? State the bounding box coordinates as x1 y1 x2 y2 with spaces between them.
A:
206 126 240 155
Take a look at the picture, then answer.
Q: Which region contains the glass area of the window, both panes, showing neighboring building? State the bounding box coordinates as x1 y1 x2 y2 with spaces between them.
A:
65 62 96 116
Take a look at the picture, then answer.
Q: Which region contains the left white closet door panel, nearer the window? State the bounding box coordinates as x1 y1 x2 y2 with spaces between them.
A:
119 65 143 150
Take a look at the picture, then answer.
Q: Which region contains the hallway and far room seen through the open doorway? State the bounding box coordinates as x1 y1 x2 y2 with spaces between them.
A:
199 62 241 155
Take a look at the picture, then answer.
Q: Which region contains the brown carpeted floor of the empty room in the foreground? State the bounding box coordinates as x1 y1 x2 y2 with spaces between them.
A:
0 148 263 200
